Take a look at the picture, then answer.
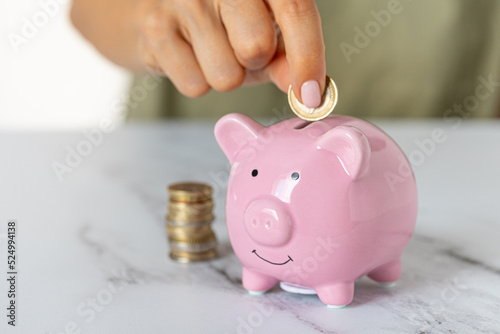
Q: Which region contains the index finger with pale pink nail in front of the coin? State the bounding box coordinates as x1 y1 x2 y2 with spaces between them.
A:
268 0 326 108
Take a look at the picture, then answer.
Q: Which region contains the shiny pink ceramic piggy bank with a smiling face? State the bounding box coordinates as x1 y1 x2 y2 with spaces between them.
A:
215 114 417 307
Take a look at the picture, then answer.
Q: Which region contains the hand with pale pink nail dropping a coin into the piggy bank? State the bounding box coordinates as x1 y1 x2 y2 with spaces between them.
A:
139 0 326 107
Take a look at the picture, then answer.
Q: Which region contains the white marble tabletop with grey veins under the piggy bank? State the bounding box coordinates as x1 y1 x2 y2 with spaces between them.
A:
0 120 500 334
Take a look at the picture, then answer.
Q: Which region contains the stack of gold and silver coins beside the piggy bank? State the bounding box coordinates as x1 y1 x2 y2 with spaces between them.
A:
167 183 217 263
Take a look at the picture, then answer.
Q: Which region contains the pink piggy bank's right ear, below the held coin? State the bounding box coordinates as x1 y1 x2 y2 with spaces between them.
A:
316 126 371 180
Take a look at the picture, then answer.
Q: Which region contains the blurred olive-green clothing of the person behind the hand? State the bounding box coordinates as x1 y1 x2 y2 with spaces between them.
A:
129 0 500 118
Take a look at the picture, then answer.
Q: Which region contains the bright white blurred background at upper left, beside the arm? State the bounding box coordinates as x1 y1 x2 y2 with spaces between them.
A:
0 0 130 130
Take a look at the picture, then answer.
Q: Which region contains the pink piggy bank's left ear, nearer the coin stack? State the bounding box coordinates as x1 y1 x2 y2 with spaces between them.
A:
215 114 263 163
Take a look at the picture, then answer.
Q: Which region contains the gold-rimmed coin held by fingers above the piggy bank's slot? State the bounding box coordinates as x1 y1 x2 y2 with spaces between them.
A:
288 76 338 121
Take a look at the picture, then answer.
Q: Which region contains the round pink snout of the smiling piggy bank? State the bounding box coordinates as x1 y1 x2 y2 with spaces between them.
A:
244 199 292 246
